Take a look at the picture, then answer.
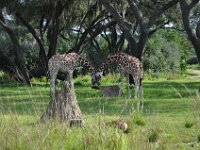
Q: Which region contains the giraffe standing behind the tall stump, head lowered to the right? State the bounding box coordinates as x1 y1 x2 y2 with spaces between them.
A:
48 53 94 99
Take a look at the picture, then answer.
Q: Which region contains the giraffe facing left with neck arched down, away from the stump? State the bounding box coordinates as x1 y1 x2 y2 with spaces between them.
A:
92 52 143 98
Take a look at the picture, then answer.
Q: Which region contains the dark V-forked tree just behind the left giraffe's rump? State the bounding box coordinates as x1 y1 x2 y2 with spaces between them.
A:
14 0 72 76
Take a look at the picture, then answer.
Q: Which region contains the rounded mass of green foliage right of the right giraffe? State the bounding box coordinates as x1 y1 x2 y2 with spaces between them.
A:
143 30 190 73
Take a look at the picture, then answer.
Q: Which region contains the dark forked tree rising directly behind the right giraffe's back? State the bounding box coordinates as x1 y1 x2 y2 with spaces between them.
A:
100 0 178 58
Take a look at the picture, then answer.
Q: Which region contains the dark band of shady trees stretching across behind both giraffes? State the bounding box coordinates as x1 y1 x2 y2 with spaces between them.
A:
0 0 200 84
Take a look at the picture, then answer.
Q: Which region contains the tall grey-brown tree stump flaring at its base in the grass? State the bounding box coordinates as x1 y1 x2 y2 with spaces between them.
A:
41 81 84 127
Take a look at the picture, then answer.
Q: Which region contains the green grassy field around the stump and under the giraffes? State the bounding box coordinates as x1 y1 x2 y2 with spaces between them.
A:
0 76 200 150
